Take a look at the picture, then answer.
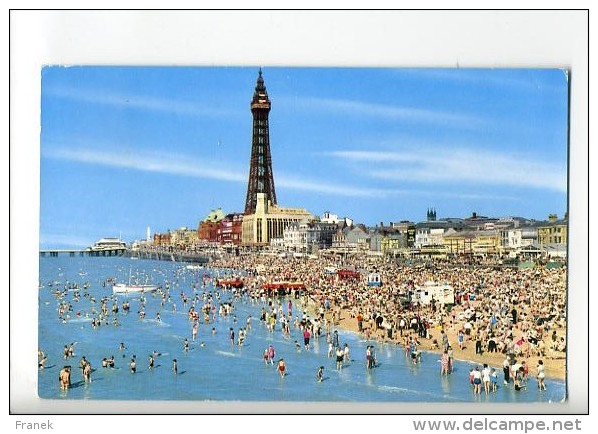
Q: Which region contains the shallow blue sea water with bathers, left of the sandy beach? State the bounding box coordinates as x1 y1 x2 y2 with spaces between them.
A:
38 256 566 403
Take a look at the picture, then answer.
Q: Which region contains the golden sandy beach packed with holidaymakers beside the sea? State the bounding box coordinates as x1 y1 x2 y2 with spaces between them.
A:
213 255 567 380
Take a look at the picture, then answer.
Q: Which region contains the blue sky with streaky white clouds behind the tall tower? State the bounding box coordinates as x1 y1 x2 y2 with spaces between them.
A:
40 65 568 248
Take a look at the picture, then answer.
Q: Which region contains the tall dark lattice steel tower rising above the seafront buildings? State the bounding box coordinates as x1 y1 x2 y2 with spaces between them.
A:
245 68 276 214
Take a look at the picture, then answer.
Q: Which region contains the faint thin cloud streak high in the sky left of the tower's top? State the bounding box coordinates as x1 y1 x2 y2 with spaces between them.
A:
43 87 234 117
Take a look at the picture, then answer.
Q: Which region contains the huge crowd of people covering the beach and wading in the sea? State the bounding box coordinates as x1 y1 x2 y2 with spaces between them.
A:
38 254 567 394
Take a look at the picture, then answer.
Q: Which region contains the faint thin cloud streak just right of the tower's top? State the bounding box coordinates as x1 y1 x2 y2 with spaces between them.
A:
282 97 486 128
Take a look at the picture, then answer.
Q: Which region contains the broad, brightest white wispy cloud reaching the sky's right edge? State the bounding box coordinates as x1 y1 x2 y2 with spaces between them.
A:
331 148 567 192
